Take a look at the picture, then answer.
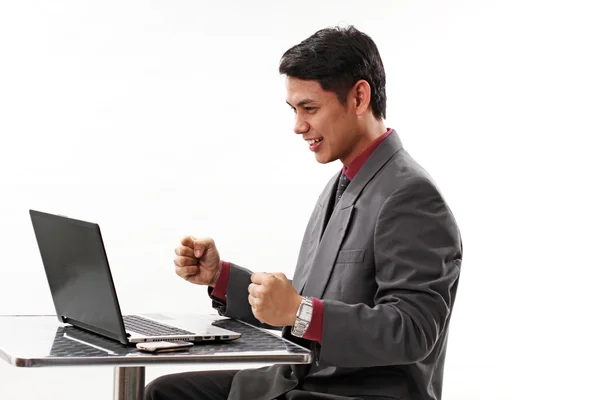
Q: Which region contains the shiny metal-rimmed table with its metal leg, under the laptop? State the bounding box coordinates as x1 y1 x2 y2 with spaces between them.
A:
0 315 312 400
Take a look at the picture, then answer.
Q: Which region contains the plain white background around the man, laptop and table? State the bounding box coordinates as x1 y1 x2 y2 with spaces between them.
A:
0 0 600 400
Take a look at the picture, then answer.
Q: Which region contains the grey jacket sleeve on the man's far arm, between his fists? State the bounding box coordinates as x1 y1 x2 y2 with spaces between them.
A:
208 263 281 329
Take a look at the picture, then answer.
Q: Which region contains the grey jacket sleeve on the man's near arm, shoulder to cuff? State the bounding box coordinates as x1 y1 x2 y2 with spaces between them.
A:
316 178 462 367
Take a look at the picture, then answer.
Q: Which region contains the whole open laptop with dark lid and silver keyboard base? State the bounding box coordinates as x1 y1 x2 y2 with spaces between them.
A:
29 210 241 345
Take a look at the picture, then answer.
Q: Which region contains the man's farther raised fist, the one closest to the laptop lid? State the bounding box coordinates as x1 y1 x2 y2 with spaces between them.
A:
174 236 221 287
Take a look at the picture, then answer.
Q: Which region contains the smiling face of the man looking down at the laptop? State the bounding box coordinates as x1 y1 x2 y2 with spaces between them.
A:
286 77 360 165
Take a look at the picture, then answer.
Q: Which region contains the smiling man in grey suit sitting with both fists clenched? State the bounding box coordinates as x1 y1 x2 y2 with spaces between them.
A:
146 27 462 400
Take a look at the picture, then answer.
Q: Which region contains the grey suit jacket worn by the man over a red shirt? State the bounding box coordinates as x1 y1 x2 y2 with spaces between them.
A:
209 132 462 400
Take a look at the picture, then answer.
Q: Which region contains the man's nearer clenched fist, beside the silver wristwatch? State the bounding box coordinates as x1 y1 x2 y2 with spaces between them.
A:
248 272 302 326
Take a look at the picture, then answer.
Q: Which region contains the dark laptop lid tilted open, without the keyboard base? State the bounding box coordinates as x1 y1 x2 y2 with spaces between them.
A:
29 210 126 342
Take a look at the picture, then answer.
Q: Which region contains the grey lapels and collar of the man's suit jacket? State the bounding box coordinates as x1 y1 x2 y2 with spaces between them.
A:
301 131 402 299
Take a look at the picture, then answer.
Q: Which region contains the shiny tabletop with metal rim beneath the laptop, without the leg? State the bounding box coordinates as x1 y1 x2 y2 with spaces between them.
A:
0 316 310 366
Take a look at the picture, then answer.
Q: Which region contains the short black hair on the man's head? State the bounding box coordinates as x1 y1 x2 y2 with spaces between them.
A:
279 25 386 119
